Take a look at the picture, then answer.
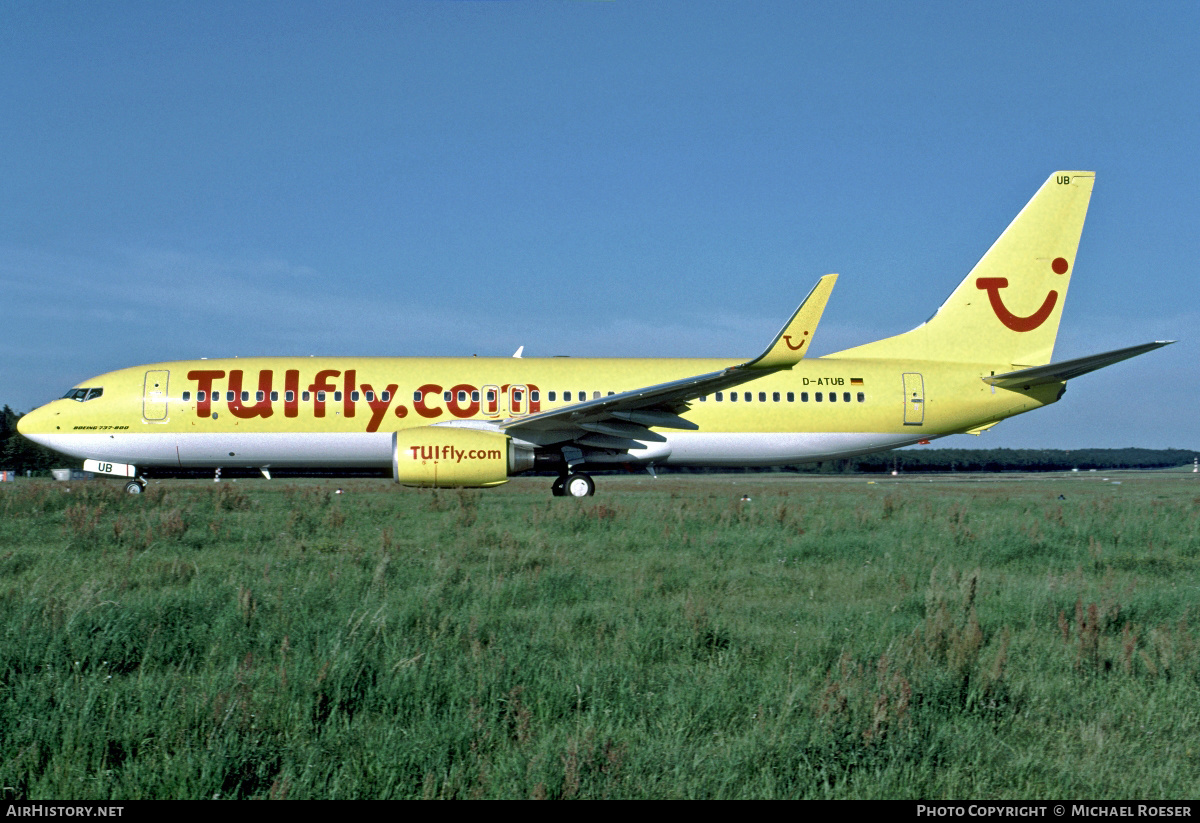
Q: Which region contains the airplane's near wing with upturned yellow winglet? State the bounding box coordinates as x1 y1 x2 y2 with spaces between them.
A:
500 275 838 450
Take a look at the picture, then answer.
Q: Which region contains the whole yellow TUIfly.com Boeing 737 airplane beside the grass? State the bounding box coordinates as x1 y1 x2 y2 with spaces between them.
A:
19 172 1170 497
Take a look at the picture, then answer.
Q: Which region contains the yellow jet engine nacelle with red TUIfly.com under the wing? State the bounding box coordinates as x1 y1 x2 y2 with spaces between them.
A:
391 426 533 488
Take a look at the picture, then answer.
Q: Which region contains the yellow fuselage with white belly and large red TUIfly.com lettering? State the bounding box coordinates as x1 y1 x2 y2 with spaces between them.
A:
20 358 1061 468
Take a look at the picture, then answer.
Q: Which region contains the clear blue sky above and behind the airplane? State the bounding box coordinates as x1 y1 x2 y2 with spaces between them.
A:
0 0 1200 449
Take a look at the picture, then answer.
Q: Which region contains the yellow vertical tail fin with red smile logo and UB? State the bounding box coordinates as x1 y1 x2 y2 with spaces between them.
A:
830 172 1096 367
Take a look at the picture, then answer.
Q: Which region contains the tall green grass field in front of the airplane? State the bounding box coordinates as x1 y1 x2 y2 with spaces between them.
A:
0 473 1200 799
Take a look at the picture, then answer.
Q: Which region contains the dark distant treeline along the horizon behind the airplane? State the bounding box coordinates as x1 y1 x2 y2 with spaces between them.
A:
0 406 1200 474
